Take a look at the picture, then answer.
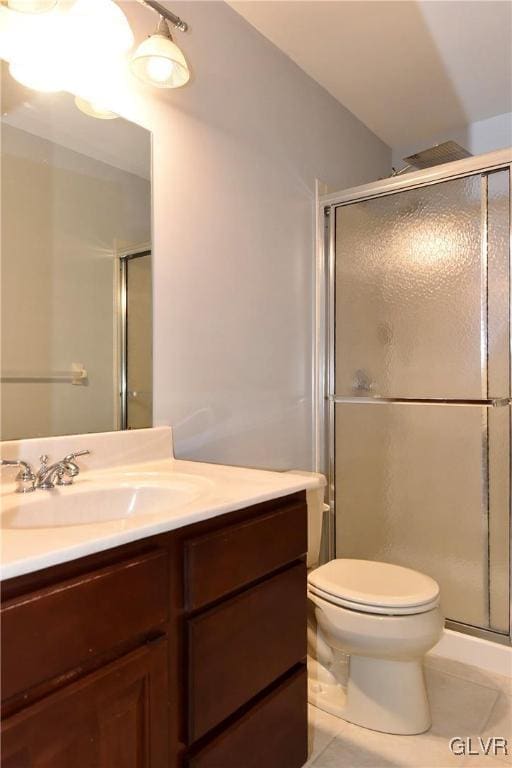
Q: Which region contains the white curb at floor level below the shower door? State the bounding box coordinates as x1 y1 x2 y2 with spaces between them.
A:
429 629 512 677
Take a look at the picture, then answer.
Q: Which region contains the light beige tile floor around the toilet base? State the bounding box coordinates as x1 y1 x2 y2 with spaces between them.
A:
305 656 512 768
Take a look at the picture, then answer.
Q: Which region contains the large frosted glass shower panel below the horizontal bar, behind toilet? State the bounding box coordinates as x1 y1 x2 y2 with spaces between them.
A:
336 403 492 627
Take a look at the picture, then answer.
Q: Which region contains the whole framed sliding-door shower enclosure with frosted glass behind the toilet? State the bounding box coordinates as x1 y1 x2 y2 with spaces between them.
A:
319 151 512 642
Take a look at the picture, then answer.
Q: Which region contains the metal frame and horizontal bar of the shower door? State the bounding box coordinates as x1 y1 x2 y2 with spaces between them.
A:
320 148 512 644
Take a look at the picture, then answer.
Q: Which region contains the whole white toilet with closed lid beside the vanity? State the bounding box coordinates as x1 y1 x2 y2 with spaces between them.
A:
307 492 443 735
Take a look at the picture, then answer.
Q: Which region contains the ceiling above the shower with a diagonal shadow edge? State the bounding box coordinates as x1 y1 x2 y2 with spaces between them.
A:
228 0 512 147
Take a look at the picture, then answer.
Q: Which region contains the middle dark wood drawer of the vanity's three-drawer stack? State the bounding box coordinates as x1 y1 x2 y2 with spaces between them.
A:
187 563 306 743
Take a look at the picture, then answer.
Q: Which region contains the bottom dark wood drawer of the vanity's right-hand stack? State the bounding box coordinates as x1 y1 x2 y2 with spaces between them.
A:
187 667 308 768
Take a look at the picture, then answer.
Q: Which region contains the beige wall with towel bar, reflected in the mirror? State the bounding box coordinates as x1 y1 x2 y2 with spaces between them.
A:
1 125 151 439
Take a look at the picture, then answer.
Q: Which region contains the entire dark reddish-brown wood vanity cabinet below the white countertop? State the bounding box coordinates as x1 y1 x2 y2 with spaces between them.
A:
1 493 307 768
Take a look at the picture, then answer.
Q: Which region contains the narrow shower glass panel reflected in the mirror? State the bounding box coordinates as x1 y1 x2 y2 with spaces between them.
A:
126 255 153 429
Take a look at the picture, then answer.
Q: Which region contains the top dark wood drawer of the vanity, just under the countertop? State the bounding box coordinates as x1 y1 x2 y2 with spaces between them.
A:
185 495 307 610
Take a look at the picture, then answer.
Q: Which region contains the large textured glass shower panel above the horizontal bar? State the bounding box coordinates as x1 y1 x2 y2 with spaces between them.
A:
336 176 486 399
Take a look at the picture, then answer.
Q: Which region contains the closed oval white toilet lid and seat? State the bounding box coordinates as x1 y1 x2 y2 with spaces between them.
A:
308 558 439 613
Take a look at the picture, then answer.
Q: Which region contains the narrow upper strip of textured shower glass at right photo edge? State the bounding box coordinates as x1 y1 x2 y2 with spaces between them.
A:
487 170 510 397
